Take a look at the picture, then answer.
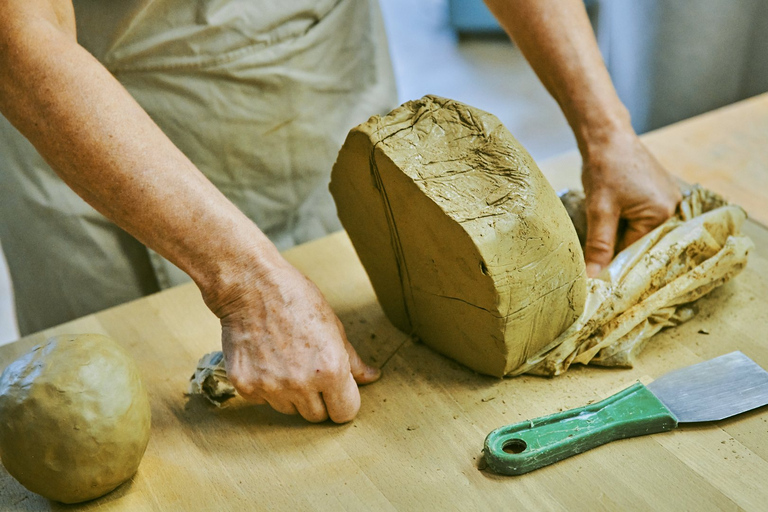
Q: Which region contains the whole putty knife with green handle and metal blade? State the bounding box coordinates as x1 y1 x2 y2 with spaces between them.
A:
483 352 768 475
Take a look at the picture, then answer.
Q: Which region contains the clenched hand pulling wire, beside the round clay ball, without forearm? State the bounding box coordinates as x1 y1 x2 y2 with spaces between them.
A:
212 263 380 423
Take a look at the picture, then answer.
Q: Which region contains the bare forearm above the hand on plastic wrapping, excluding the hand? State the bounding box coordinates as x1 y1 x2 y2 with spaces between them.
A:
486 0 634 154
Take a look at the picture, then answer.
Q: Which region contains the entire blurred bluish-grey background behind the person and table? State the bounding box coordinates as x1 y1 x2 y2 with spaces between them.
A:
0 0 768 344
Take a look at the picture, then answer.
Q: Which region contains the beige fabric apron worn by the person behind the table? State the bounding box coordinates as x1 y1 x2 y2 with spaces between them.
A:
0 0 396 334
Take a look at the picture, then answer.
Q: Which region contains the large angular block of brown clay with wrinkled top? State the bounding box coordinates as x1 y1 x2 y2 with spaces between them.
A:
330 96 586 376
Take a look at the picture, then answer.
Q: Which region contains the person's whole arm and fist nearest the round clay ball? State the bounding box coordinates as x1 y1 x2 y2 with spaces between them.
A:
0 0 379 422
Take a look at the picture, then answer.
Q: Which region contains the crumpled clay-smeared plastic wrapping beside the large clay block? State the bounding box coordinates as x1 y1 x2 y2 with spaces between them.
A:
512 187 753 376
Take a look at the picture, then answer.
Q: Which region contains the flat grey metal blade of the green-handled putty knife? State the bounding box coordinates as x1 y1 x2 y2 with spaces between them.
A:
646 352 768 423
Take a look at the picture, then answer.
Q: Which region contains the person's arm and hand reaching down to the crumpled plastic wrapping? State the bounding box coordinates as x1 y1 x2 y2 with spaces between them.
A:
485 0 680 276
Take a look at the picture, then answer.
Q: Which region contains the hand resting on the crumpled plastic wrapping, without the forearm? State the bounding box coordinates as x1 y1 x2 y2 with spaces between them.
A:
581 133 682 277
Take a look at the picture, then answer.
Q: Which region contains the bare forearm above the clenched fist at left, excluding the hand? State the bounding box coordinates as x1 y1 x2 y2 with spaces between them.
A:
0 3 279 312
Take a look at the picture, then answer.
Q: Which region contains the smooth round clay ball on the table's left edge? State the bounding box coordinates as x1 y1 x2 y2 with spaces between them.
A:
0 334 150 503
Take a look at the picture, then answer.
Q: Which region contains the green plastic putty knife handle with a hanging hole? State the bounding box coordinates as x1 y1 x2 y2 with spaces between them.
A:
483 382 677 475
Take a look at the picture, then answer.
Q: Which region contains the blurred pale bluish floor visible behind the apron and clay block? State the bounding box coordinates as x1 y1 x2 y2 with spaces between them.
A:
0 0 576 344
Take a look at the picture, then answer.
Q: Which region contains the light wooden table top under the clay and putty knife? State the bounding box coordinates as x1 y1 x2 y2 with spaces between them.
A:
0 96 768 511
